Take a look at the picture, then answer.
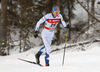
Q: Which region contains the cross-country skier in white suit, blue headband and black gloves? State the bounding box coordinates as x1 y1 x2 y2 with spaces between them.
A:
34 6 69 66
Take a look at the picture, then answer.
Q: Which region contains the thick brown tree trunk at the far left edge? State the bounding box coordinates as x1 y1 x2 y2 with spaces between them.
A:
0 0 9 54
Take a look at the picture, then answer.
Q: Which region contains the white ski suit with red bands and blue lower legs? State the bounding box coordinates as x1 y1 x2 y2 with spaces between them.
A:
35 13 66 64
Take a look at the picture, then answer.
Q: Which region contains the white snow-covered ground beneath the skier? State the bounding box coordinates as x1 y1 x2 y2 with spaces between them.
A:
0 44 100 72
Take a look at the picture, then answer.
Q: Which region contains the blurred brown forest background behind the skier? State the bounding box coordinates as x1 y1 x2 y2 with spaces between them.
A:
0 0 100 55
